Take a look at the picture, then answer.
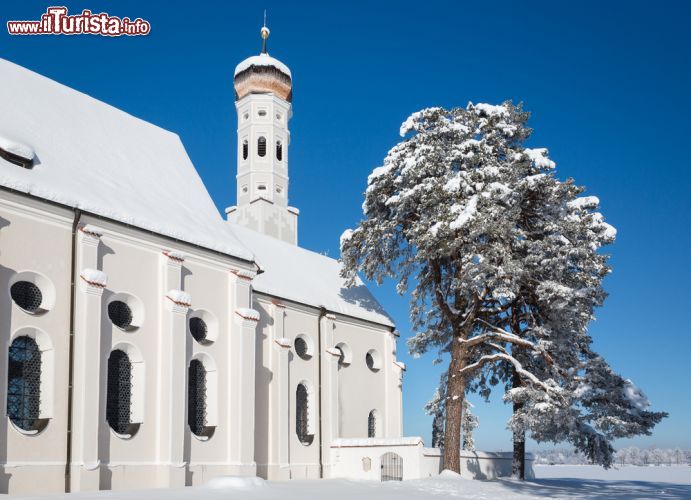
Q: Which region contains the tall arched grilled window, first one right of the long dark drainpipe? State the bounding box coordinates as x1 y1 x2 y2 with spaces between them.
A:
106 349 132 434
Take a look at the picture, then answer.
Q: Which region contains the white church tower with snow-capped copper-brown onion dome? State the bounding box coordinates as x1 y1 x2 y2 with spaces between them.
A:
226 23 299 245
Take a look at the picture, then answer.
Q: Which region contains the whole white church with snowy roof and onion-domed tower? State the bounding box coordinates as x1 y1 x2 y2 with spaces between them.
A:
0 25 470 493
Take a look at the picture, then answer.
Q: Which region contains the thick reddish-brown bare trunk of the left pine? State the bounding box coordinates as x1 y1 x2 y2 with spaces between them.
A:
444 336 466 474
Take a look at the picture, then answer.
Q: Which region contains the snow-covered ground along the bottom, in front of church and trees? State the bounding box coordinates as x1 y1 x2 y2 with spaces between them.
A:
9 465 691 500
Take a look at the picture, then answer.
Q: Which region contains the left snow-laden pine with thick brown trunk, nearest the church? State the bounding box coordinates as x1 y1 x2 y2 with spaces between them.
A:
341 102 561 472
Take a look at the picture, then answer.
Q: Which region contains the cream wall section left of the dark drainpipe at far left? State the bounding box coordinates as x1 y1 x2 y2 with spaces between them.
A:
0 193 72 493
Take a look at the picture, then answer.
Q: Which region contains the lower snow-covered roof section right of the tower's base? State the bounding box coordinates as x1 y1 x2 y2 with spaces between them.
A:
230 224 394 326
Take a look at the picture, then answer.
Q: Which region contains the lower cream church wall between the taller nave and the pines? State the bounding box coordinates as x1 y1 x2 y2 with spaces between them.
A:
254 294 402 479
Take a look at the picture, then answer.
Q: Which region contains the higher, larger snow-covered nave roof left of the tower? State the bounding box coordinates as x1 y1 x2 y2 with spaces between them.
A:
0 59 253 260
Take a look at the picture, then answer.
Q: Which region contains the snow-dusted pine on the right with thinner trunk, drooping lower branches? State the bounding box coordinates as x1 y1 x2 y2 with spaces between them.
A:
493 147 666 472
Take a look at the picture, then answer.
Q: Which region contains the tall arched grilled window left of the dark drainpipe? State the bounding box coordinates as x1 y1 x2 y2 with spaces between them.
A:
7 336 41 431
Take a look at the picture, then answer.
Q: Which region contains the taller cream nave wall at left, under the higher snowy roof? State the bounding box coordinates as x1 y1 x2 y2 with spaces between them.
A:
0 191 256 493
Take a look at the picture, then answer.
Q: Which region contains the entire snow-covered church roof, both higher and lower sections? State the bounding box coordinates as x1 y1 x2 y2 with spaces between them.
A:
0 59 393 326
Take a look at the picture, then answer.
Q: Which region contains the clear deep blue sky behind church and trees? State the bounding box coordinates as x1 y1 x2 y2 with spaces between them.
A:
0 0 691 449
